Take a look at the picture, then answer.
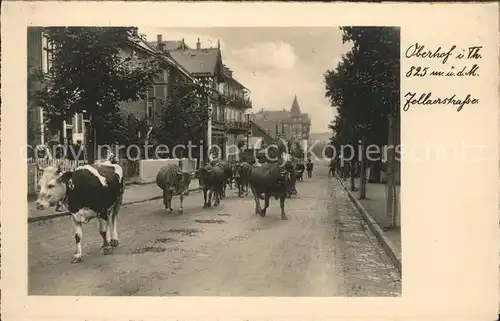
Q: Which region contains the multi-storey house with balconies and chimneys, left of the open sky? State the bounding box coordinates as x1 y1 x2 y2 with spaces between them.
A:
148 35 252 156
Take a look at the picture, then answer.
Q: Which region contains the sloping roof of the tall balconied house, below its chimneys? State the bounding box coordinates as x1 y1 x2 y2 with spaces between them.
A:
170 48 220 76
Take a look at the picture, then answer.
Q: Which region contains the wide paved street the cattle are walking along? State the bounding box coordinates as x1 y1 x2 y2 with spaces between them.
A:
28 164 401 296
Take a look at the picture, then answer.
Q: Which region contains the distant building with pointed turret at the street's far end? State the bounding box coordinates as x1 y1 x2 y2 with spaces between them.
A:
253 96 311 141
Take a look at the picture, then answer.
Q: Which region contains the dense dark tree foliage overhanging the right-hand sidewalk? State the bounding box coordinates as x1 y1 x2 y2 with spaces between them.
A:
325 27 400 184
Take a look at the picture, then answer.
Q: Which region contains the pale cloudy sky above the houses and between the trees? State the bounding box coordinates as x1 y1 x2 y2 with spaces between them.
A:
139 27 350 133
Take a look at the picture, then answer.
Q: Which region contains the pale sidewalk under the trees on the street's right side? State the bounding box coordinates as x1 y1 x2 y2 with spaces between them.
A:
336 178 401 271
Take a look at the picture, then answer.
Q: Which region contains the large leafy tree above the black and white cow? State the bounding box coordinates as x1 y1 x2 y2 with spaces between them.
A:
38 27 161 163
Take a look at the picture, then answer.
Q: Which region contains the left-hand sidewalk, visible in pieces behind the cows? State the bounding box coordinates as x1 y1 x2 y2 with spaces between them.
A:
28 179 200 223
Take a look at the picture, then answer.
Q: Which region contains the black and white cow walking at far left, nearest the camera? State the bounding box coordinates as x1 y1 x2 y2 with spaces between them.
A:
36 162 124 263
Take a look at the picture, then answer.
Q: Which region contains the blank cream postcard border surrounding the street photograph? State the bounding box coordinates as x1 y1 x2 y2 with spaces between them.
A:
1 2 499 320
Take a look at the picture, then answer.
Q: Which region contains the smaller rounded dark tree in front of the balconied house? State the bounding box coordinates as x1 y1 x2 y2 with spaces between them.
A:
151 78 210 157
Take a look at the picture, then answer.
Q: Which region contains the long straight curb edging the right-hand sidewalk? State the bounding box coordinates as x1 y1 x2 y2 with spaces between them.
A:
335 176 403 275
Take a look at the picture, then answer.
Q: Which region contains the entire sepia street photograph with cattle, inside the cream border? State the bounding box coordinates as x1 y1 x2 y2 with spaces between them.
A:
26 26 402 297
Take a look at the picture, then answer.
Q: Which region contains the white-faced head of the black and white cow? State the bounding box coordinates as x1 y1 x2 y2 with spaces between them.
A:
35 166 72 210
